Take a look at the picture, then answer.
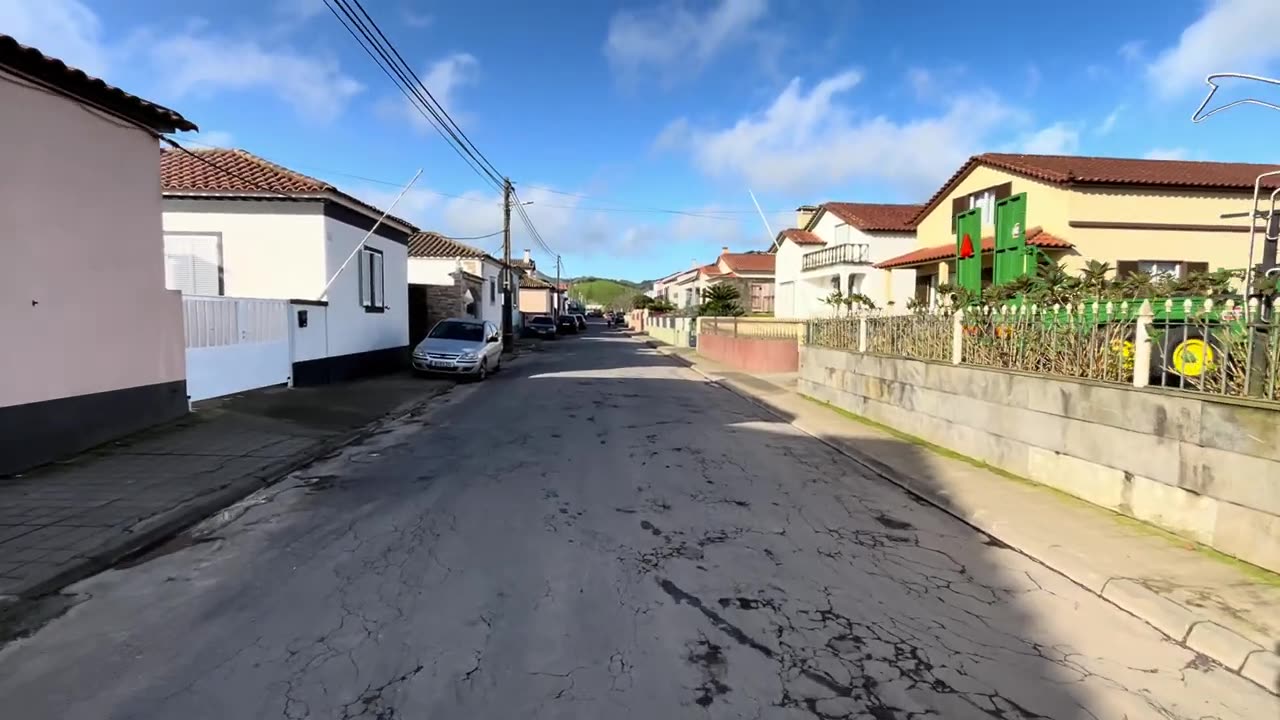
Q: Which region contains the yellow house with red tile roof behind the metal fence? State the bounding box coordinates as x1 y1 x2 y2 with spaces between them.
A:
876 152 1280 301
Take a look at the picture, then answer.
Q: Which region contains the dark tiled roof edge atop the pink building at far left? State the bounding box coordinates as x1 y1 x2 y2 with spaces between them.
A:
0 35 198 133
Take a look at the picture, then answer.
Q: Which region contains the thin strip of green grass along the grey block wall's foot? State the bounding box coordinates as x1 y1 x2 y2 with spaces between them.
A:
800 393 1280 587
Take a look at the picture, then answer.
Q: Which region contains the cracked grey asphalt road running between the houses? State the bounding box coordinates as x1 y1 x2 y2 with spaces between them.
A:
0 328 1280 720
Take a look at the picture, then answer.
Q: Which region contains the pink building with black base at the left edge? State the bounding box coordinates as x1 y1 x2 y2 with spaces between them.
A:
0 35 196 474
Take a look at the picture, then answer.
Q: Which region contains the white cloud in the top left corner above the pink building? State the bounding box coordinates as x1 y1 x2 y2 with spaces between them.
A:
0 0 111 77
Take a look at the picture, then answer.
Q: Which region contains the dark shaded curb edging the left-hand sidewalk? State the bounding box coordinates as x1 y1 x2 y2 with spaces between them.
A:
0 387 452 614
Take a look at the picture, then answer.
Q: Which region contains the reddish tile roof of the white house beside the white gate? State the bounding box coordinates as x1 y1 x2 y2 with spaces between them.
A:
160 149 416 229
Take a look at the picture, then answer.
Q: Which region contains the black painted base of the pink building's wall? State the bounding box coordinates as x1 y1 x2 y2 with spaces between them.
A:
0 380 188 475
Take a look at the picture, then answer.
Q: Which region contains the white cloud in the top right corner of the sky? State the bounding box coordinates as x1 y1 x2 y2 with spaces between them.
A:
1147 0 1280 99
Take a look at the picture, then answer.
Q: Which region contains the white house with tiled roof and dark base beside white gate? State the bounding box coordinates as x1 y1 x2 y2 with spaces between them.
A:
160 150 417 384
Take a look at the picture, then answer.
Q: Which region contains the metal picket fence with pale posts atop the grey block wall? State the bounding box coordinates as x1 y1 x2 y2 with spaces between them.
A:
805 299 1280 401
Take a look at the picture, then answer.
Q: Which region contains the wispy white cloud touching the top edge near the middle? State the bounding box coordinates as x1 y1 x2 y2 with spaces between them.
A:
604 0 768 79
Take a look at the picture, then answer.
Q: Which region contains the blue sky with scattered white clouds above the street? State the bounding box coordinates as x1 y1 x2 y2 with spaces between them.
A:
0 0 1280 279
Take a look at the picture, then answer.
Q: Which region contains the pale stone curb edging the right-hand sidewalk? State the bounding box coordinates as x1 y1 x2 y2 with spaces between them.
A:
645 340 1280 696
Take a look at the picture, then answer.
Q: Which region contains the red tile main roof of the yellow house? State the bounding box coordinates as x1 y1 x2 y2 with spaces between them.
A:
914 152 1280 223
